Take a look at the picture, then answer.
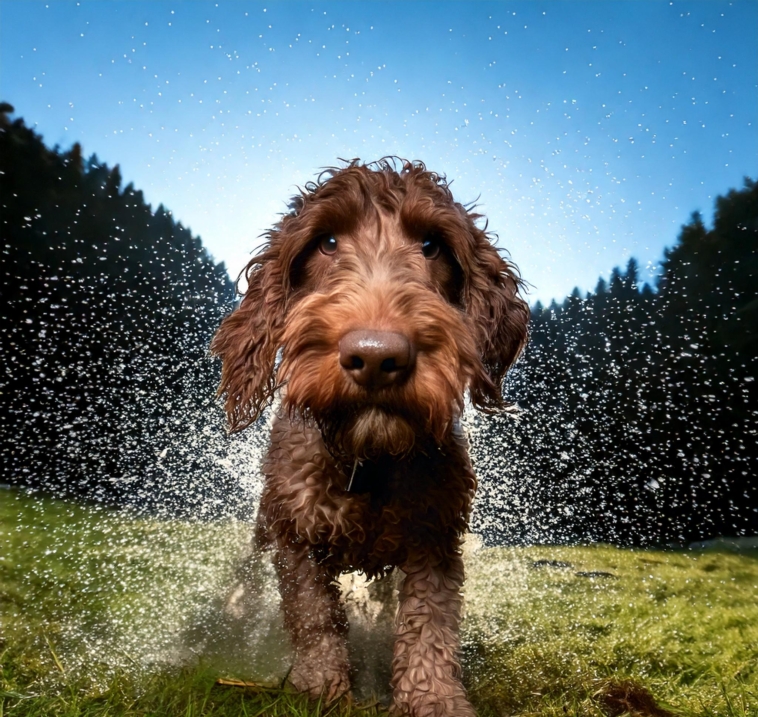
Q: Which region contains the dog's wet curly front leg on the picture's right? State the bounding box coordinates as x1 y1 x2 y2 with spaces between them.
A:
392 555 474 717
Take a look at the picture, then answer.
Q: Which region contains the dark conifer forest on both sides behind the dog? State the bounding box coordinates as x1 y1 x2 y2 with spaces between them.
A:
0 99 758 544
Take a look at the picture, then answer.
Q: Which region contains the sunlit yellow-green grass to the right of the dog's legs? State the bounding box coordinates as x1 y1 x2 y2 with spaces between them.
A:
464 546 758 717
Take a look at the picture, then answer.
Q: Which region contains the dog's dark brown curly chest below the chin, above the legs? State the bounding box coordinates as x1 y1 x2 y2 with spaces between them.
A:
261 426 475 574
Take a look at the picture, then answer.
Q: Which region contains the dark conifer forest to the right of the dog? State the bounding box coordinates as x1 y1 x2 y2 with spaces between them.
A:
475 179 758 544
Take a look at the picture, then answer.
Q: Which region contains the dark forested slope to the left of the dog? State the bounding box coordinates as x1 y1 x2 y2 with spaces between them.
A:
0 103 243 504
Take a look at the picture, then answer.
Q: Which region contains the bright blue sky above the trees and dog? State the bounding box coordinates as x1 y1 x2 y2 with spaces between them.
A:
0 0 758 301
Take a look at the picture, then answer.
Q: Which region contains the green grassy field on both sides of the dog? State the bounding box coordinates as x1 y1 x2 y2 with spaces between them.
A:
0 490 758 717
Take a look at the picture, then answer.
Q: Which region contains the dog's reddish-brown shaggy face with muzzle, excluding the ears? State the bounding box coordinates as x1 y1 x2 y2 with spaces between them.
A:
278 206 479 458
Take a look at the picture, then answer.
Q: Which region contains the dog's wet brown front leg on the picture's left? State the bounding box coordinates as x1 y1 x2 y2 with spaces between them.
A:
275 537 350 701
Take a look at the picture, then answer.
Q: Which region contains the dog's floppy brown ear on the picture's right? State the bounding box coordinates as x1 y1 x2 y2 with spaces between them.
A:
464 227 529 410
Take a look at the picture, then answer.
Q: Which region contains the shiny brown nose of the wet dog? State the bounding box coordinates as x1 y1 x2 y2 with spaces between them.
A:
340 330 413 388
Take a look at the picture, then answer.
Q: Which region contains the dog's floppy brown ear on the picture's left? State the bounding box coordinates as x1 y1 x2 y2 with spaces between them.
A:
211 239 288 432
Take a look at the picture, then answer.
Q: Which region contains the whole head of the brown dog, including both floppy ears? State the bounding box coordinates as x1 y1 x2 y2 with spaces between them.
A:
211 160 529 458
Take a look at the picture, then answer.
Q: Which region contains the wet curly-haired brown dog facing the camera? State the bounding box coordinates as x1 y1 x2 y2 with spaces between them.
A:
211 158 529 717
